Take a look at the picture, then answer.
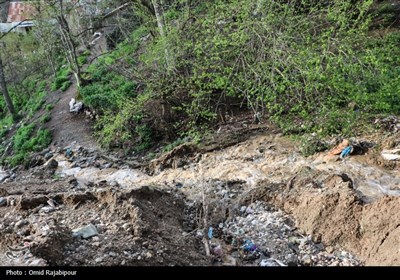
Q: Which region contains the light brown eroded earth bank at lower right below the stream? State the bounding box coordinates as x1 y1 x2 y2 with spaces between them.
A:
240 172 400 266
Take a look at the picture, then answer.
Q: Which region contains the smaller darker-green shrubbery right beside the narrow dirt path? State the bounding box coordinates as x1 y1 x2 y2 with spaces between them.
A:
79 28 155 151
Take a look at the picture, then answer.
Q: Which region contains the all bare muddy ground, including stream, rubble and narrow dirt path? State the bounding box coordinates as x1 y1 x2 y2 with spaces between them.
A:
0 76 400 266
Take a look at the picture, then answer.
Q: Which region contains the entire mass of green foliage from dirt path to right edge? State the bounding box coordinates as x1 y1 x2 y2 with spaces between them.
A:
80 0 400 154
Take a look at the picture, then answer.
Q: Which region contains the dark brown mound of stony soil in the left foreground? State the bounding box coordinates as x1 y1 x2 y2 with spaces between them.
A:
0 187 209 266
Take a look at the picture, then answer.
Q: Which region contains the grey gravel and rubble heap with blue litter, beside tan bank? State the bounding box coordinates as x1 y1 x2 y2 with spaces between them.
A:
206 201 361 266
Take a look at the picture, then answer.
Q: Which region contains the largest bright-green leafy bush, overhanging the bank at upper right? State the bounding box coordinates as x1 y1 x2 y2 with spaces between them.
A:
141 0 400 138
